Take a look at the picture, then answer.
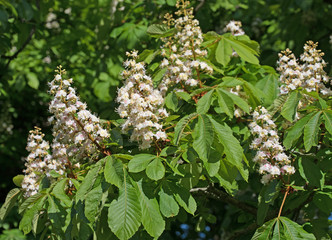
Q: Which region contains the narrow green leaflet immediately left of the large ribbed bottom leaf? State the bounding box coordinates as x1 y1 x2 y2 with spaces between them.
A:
84 184 103 223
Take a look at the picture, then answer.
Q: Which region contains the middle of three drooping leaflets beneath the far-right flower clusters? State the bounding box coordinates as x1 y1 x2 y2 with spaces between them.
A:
303 112 321 152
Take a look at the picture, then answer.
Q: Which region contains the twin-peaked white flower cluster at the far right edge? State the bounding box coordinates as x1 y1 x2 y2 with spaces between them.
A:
277 41 331 95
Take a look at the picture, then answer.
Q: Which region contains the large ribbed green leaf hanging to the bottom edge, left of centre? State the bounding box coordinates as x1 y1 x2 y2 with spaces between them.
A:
108 180 142 240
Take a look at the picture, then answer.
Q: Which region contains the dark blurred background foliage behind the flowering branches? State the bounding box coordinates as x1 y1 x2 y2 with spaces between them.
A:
0 0 332 239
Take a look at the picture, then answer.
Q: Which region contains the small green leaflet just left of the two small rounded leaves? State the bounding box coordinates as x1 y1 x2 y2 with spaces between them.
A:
104 156 124 188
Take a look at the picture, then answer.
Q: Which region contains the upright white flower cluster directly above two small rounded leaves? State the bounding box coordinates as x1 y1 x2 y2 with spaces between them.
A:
116 51 168 149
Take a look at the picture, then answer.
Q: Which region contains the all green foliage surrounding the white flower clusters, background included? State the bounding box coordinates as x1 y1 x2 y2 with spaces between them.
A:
0 0 332 239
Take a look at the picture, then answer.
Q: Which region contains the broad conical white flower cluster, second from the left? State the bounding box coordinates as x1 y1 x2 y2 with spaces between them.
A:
49 66 110 163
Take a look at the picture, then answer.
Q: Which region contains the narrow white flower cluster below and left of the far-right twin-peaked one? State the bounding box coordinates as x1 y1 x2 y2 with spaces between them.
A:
249 106 295 184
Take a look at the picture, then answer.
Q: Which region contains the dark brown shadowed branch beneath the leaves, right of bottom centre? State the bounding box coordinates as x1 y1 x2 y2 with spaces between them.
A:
190 186 257 216
